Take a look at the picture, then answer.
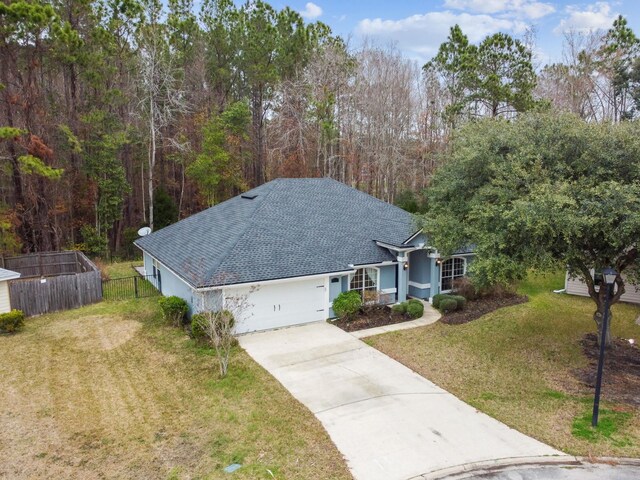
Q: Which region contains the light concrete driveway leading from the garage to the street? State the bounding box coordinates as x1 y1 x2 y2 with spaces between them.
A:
239 322 563 480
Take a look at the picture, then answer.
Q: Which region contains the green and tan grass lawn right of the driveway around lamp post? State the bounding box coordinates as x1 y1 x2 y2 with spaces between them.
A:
368 274 640 457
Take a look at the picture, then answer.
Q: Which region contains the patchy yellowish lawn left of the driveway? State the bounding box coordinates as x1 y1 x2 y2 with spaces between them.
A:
0 299 351 479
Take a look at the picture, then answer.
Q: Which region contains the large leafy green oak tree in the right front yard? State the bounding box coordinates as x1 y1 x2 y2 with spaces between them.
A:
422 114 640 345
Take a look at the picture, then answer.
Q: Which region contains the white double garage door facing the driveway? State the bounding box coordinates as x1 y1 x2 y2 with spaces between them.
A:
225 278 328 333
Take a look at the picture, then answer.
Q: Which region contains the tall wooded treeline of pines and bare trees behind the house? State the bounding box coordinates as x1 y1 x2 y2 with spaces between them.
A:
0 0 640 254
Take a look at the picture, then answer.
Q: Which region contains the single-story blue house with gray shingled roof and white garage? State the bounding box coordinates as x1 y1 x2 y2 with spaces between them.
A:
135 178 472 333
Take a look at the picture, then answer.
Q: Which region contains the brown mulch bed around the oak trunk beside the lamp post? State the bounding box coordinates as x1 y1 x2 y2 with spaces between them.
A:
573 333 640 406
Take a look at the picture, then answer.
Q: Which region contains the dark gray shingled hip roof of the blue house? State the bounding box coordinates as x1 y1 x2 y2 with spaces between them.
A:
135 178 416 287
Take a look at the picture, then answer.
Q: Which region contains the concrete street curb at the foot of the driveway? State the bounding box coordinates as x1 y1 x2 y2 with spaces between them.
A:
407 455 640 480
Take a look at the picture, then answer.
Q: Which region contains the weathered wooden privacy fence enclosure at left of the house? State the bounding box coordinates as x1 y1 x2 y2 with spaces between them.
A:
3 251 102 316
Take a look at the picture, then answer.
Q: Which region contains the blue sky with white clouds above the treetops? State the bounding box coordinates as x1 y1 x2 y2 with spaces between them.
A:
271 0 640 64
